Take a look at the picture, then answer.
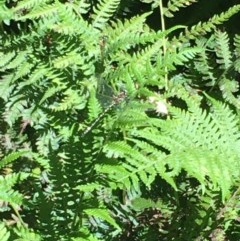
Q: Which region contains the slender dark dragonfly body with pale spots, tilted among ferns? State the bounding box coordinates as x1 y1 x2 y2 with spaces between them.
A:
81 91 126 137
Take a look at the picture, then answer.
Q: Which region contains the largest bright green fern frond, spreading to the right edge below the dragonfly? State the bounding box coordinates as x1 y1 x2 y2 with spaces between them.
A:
102 95 240 199
